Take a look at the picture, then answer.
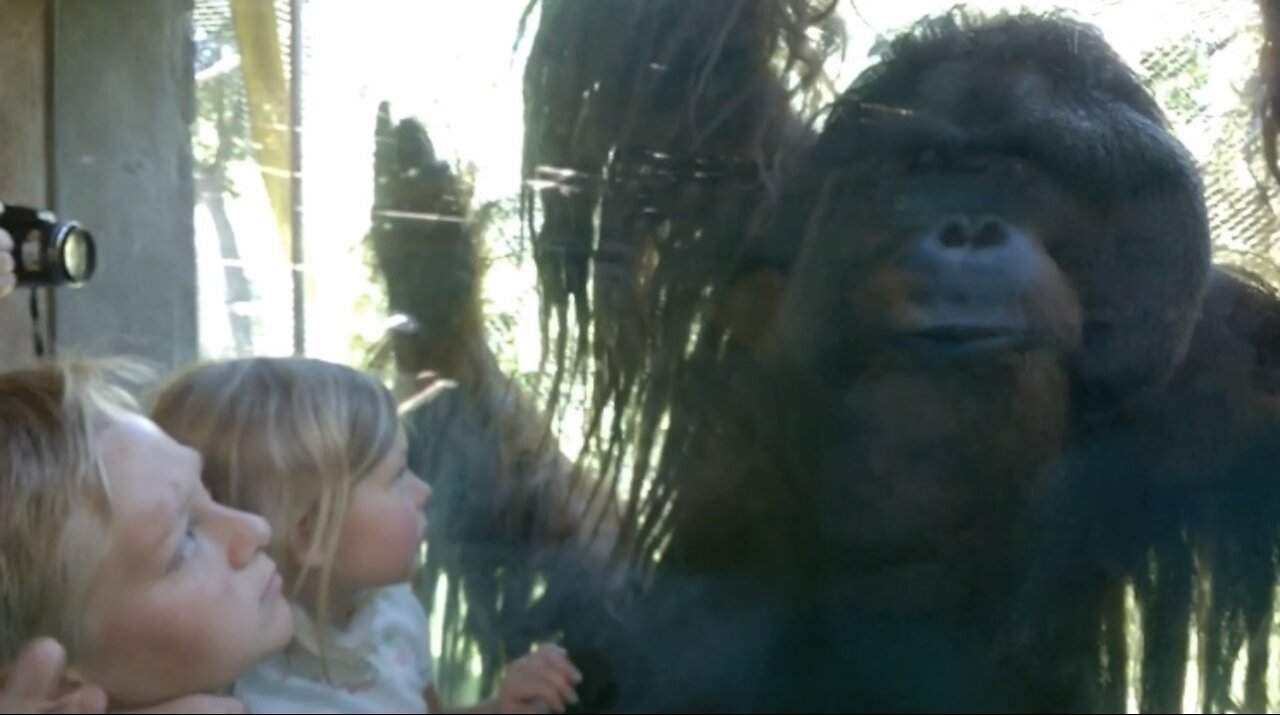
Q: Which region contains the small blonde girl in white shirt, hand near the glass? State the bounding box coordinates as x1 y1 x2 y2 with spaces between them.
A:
152 358 580 712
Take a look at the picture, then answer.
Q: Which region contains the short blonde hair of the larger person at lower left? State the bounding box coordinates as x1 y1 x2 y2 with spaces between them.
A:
0 359 141 664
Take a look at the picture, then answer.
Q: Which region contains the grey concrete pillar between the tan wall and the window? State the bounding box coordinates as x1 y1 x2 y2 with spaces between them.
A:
50 0 198 376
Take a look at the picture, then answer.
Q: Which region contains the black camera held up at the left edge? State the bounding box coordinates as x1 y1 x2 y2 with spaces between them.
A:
0 203 97 288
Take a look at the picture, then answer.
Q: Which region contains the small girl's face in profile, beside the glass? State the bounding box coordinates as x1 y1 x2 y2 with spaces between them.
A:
333 432 431 588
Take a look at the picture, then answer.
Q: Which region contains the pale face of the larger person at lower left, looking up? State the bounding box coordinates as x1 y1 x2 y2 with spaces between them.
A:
77 416 293 703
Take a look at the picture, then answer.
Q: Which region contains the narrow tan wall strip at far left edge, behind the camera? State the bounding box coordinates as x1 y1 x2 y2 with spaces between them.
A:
0 0 47 370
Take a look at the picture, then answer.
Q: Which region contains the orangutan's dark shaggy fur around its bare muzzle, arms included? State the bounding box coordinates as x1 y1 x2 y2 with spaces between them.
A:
374 0 1280 712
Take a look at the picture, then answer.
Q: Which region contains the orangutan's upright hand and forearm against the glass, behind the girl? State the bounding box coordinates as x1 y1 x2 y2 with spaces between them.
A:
370 104 618 697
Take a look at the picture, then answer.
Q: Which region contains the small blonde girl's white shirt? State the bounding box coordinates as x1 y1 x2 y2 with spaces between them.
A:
236 585 431 712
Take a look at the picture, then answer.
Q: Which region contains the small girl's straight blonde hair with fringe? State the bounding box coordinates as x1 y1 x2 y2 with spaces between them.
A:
152 358 399 649
